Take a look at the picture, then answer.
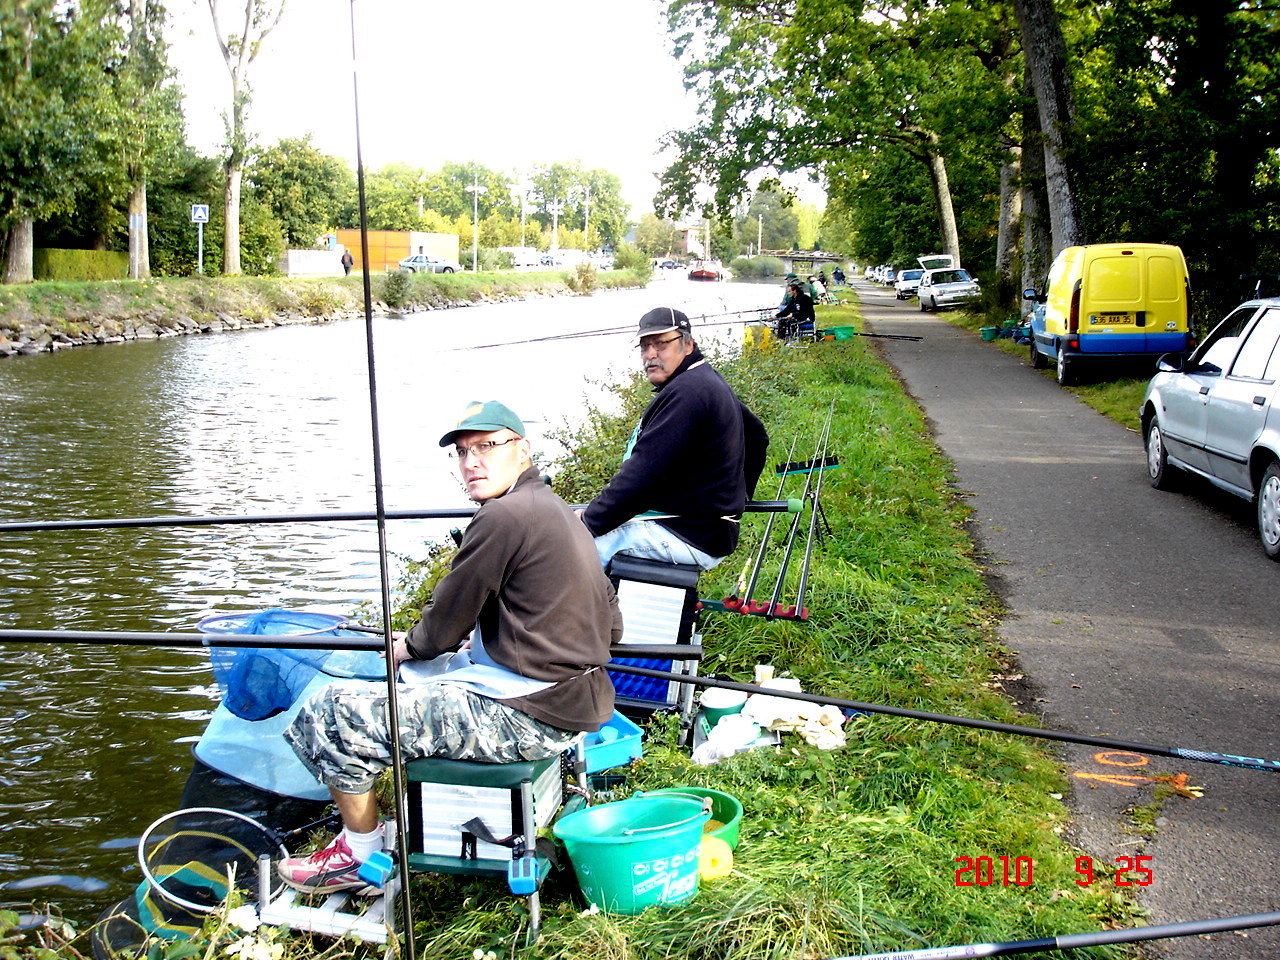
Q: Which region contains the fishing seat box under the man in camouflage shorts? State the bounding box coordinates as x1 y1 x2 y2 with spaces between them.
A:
404 754 564 876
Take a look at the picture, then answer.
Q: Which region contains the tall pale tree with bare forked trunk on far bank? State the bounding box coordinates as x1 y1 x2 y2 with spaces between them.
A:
209 0 285 274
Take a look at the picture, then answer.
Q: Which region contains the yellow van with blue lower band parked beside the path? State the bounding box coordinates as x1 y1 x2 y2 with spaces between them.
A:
1023 243 1194 384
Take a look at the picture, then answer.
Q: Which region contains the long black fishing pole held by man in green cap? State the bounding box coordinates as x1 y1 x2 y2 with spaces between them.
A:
0 627 1280 773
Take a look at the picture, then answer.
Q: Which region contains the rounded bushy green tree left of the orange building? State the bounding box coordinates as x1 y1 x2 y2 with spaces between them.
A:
244 134 355 248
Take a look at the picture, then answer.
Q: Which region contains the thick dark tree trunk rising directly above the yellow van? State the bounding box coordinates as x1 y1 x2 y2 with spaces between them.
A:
1014 0 1089 253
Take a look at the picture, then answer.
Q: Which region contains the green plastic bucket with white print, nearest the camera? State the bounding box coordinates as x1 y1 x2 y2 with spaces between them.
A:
552 794 712 914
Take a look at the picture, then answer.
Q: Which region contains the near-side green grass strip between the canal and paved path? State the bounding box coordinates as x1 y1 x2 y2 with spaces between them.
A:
5 306 1132 960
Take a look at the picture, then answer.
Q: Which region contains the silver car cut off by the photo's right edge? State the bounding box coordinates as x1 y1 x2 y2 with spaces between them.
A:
1139 298 1280 561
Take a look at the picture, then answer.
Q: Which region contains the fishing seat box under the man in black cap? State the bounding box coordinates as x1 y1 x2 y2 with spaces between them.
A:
605 554 703 719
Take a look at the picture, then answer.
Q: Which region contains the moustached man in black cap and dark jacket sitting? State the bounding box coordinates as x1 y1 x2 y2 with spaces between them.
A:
582 307 769 570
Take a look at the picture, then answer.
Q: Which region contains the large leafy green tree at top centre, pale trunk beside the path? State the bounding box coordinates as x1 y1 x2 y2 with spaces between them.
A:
658 0 1016 264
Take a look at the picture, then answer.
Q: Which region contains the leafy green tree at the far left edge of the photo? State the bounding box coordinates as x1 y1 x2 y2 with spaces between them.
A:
0 0 119 283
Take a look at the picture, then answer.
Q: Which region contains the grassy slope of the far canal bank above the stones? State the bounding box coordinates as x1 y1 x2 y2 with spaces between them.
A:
0 270 644 339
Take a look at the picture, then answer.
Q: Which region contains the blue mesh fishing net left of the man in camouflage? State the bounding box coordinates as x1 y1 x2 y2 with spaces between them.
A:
196 611 347 721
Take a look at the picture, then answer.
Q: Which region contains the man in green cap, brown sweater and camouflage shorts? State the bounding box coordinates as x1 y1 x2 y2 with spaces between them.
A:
279 401 622 893
